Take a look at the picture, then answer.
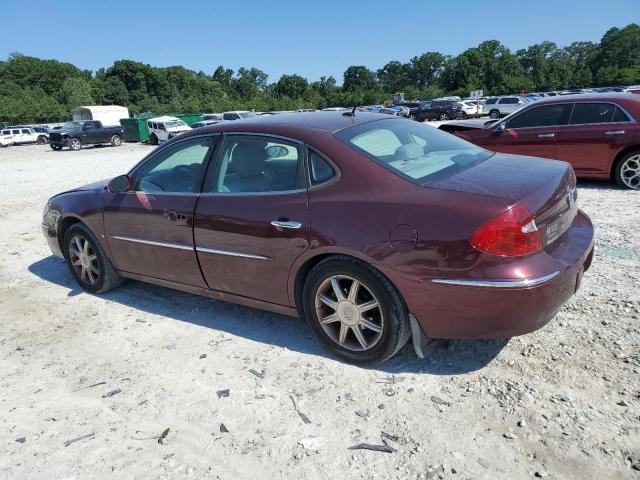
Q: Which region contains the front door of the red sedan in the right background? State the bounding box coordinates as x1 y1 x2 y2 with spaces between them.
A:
483 103 571 159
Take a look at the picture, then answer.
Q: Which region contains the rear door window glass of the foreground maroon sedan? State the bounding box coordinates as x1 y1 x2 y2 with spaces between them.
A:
210 135 305 193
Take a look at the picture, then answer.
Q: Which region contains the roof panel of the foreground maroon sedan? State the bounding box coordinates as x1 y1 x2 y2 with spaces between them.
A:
192 111 397 133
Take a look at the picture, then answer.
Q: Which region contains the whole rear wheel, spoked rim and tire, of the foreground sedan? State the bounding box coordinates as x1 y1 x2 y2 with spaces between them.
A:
303 256 410 364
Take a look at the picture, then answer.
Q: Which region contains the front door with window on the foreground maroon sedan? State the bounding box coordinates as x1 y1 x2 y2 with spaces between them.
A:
104 136 217 287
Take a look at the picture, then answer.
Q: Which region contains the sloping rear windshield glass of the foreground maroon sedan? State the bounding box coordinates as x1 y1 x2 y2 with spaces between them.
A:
336 119 493 183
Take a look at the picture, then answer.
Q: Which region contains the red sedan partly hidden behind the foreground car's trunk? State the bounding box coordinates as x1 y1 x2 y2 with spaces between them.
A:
440 93 640 190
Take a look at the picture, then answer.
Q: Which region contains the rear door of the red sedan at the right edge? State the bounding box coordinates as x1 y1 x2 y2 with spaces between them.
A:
556 102 638 175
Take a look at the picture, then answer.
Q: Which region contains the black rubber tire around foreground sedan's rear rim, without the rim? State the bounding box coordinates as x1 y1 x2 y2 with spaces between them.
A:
302 255 411 364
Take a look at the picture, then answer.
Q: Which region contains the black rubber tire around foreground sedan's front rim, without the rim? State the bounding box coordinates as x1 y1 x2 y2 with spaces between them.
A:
62 223 124 293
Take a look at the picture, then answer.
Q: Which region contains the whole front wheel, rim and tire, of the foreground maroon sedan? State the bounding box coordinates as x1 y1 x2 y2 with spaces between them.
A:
63 223 123 293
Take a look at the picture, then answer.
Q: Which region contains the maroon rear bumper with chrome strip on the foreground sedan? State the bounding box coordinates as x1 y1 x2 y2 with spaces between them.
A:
399 211 594 339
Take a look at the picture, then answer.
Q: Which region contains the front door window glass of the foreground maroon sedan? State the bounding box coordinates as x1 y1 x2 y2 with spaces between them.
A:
134 137 214 193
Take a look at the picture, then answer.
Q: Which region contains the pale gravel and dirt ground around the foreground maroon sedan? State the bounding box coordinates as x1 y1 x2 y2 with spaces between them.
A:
0 145 640 479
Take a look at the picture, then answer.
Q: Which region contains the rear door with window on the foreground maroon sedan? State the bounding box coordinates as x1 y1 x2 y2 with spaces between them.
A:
194 134 309 305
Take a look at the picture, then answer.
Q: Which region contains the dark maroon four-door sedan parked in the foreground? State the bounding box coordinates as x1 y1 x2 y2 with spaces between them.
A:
43 112 593 363
